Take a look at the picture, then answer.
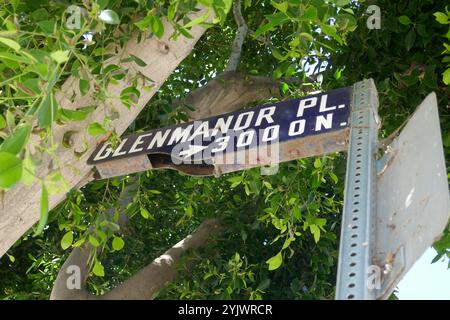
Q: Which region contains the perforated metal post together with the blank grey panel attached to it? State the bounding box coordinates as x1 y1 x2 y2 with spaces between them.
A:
336 82 450 300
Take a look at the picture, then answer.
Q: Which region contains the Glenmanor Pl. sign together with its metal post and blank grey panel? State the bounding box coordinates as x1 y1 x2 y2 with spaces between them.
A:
88 80 450 300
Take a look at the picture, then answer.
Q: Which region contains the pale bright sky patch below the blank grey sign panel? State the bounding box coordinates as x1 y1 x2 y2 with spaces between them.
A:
397 248 450 300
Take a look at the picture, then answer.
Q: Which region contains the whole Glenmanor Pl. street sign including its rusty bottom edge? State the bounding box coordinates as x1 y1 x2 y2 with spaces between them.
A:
88 87 352 178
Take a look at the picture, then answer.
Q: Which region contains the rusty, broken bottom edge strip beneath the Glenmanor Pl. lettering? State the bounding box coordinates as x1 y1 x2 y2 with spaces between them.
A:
96 128 350 178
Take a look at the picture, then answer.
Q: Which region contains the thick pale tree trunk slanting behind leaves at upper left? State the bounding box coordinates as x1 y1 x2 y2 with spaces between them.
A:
0 8 211 257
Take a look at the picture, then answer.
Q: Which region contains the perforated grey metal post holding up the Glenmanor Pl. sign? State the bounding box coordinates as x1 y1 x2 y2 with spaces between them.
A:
336 79 378 300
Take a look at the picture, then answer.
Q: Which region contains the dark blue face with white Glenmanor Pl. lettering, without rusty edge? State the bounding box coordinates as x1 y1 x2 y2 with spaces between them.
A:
87 87 352 165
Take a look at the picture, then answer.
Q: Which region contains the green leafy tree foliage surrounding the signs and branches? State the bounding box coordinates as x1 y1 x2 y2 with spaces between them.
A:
0 0 450 299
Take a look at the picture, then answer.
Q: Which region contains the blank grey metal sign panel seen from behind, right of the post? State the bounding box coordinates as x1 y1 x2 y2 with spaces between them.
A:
372 93 450 299
